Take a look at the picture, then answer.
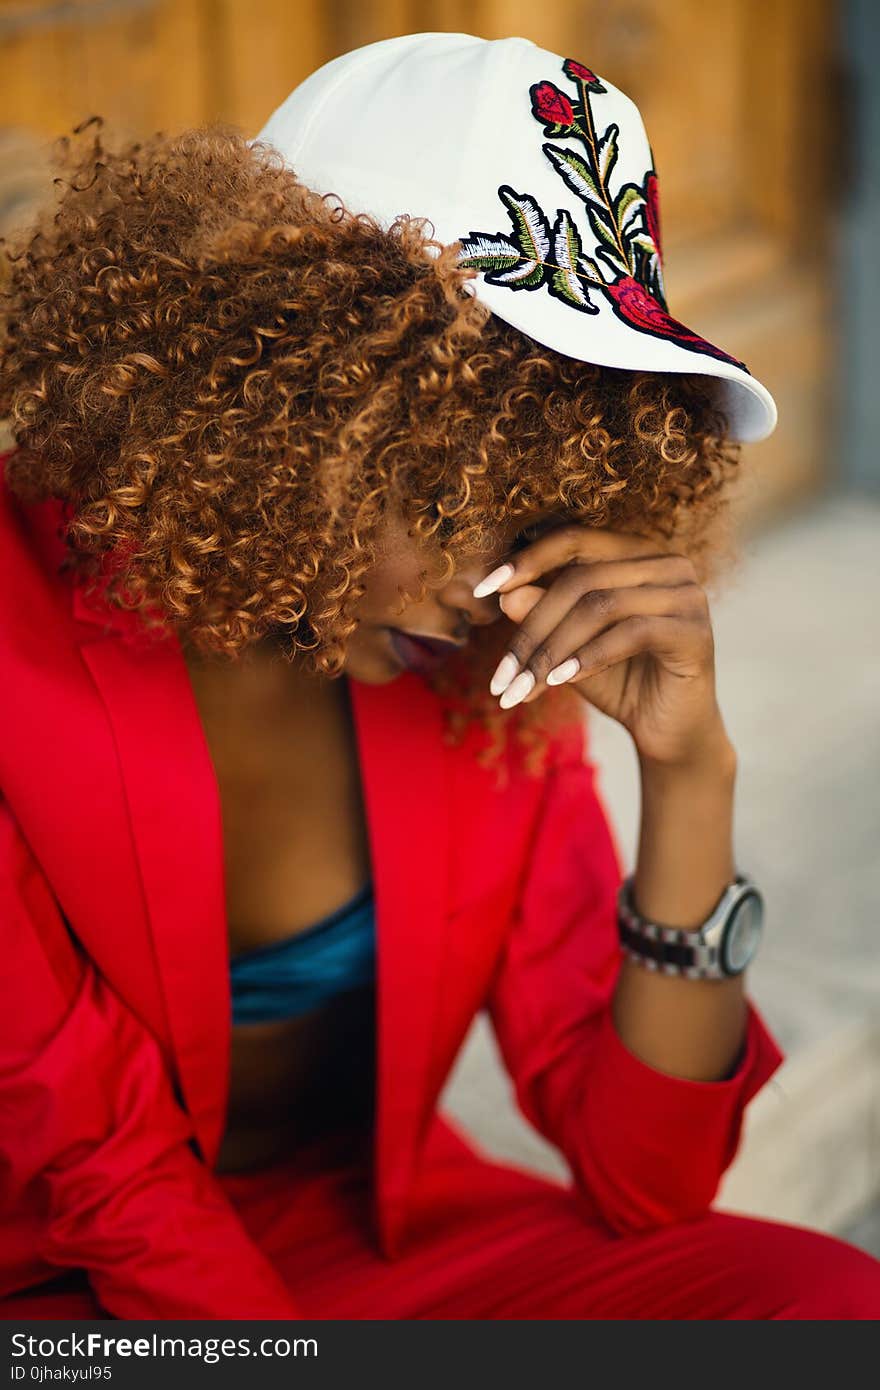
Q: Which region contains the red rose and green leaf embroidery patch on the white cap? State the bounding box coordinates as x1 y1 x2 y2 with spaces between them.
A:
459 58 748 371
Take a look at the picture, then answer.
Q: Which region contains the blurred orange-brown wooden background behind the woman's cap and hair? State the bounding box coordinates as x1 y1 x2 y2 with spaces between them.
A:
0 0 847 527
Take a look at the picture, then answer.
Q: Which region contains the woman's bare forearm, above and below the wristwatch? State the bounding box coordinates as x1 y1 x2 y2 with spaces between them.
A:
612 720 747 1081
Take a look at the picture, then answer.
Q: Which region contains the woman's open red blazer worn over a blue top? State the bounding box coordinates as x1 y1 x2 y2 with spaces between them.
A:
0 457 784 1318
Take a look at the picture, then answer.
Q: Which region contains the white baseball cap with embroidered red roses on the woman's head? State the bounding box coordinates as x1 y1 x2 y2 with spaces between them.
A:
250 33 777 442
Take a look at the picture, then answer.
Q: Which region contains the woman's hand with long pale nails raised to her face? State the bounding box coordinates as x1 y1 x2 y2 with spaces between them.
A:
474 523 727 765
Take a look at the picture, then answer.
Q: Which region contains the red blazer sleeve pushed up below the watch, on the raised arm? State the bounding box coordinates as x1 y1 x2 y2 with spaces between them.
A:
487 728 784 1233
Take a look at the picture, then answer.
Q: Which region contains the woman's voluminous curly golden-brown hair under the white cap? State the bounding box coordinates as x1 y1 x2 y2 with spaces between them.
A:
0 117 738 783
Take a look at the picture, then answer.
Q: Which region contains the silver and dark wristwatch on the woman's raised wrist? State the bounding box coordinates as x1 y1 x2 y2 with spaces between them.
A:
617 874 765 980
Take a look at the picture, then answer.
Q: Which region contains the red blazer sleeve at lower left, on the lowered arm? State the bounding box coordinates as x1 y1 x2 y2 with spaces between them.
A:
0 801 300 1319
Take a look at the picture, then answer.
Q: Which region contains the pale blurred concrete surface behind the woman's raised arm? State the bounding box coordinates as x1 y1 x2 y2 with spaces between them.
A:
441 498 880 1240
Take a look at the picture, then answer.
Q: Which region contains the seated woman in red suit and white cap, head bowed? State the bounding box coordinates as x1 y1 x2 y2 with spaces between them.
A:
0 35 880 1318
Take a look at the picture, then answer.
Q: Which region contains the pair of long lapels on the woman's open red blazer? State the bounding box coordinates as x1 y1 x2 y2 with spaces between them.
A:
72 589 449 1250
